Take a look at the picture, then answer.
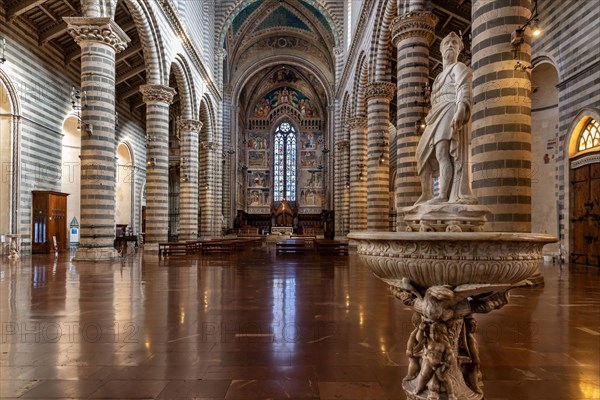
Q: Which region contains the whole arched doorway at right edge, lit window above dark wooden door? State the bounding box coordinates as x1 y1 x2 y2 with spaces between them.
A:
569 116 600 267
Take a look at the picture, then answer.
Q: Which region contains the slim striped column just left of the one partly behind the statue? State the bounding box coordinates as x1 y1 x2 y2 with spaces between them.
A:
365 82 396 231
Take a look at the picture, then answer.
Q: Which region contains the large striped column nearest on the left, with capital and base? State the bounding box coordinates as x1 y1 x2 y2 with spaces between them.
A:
65 17 129 261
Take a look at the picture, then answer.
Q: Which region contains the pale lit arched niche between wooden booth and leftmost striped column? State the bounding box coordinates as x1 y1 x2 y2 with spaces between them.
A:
60 115 81 245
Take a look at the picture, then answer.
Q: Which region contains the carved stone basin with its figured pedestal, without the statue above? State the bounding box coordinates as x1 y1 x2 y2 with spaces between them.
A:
348 231 556 400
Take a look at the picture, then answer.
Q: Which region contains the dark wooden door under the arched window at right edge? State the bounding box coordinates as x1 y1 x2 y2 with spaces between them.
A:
570 163 600 266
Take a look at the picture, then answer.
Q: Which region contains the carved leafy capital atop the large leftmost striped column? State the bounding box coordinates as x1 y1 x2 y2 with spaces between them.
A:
63 17 131 53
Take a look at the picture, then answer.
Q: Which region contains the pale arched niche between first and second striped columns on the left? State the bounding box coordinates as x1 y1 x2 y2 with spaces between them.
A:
116 143 134 235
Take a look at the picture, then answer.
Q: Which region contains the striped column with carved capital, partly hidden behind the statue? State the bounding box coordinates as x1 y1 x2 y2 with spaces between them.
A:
392 12 438 231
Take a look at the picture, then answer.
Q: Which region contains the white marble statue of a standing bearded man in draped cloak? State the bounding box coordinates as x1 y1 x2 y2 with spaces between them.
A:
415 32 477 204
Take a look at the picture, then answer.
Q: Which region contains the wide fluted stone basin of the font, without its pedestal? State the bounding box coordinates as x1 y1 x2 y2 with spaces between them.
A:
348 232 556 288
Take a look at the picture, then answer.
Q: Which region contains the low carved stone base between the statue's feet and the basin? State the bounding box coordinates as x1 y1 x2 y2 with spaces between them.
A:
403 203 492 232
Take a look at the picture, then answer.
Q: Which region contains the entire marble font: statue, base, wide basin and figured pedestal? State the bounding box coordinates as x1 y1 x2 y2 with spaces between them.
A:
348 33 556 400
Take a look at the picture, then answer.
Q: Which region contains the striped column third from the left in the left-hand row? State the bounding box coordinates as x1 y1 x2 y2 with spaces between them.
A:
177 119 202 240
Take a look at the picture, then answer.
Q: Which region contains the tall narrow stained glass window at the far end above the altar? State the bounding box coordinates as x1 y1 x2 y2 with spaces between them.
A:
273 122 296 201
